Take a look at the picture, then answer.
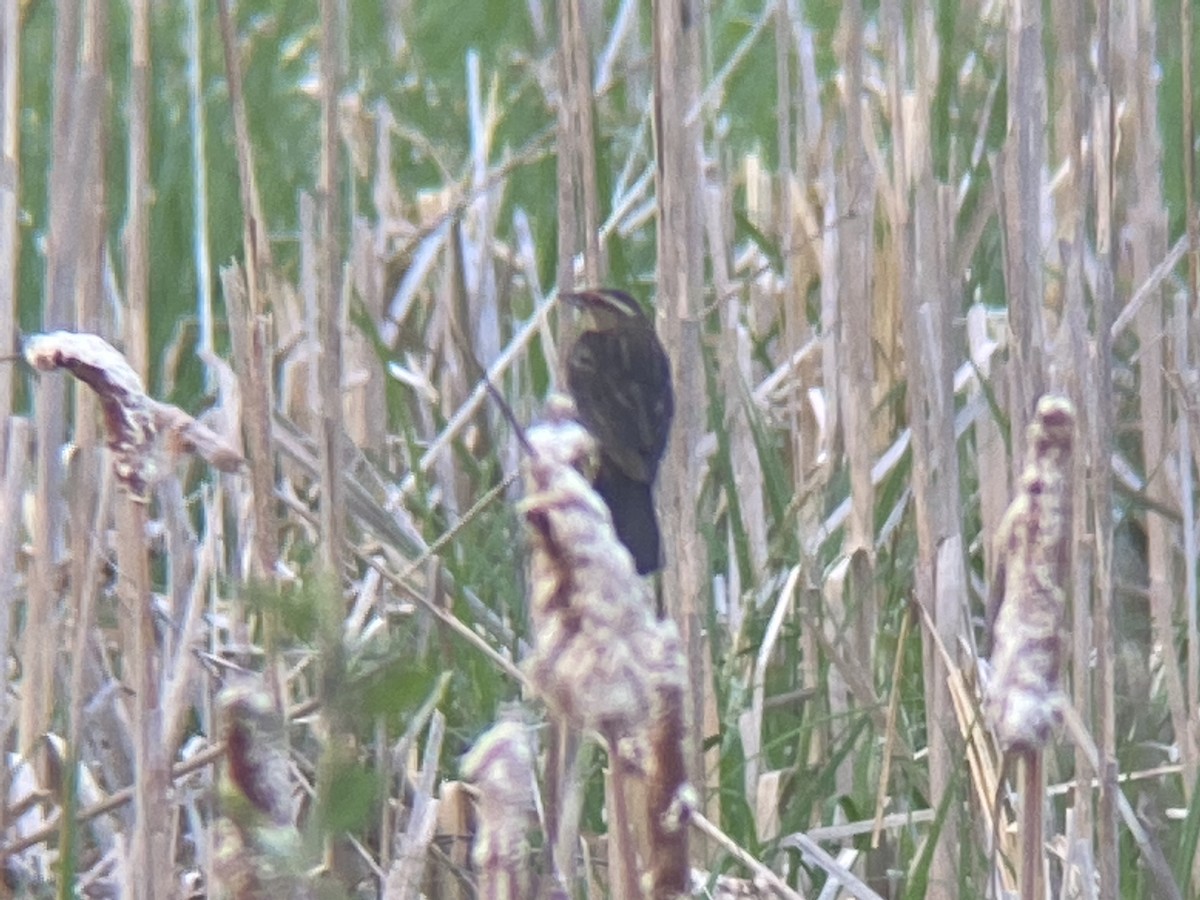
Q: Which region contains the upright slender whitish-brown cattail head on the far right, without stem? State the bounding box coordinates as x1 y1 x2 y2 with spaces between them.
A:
986 395 1075 752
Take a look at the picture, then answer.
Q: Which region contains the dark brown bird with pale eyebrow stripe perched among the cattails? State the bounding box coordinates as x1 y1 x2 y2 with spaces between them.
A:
563 288 674 575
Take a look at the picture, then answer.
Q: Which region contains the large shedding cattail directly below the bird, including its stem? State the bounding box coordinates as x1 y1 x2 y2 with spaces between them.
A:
522 409 695 898
